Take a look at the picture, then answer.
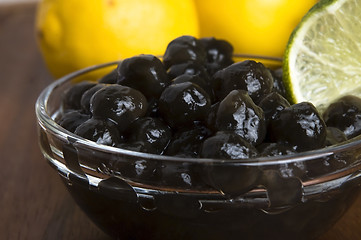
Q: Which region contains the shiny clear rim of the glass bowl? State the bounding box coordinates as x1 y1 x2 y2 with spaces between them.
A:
35 54 361 166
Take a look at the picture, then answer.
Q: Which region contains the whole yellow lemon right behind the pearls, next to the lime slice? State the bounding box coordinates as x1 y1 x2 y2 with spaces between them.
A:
195 0 317 57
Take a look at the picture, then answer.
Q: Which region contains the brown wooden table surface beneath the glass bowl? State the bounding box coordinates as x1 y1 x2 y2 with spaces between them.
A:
0 3 361 240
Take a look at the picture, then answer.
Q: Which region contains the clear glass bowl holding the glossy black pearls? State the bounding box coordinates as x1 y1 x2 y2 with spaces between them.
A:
36 56 361 240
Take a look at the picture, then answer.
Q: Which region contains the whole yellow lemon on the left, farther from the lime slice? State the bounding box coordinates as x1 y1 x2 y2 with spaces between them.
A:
36 0 199 77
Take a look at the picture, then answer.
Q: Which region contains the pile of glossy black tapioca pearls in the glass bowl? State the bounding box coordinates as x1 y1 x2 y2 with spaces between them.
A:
57 36 361 159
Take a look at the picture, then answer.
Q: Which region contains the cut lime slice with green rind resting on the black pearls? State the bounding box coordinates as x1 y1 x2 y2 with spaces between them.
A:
283 0 361 109
